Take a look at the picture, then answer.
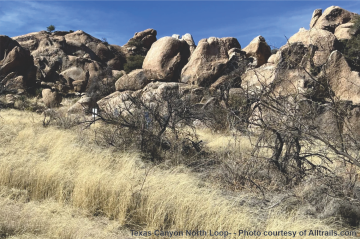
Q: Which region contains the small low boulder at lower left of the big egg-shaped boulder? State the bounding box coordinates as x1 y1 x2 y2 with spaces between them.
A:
115 69 150 91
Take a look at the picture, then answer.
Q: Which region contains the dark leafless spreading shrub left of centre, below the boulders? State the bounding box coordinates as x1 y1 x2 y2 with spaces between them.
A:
89 92 210 164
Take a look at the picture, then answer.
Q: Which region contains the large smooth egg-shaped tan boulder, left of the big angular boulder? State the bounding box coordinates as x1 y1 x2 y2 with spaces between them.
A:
143 37 190 82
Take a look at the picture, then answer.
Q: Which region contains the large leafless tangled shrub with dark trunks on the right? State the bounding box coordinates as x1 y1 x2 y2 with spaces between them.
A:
218 41 360 190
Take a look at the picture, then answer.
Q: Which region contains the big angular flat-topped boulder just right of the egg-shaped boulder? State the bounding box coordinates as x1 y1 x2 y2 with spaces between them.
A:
181 37 241 86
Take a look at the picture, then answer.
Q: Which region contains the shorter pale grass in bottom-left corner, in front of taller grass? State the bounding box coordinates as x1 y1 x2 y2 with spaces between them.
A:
0 187 130 239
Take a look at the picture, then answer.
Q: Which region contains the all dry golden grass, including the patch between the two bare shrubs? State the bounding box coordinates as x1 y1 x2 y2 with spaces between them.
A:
0 107 358 238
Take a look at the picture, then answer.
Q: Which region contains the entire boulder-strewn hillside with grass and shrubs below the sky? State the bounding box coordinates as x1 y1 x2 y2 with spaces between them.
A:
0 6 360 238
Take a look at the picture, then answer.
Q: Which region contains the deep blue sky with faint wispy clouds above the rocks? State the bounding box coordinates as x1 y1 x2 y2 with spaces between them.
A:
0 0 360 47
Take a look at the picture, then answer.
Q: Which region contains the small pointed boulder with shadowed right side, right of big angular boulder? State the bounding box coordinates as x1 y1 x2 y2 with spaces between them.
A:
243 36 271 67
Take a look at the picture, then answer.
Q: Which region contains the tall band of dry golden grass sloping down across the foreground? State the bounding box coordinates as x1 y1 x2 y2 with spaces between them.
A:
0 110 352 238
